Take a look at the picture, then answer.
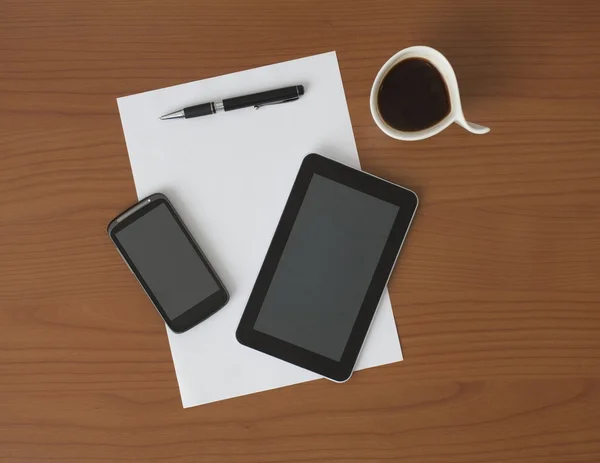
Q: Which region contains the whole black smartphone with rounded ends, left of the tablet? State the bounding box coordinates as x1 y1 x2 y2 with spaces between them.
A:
108 193 229 333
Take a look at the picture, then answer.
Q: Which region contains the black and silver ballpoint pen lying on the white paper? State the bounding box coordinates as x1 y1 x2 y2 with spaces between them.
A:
160 85 304 120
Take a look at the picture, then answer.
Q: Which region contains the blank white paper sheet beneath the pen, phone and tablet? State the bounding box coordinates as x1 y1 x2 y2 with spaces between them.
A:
117 52 402 407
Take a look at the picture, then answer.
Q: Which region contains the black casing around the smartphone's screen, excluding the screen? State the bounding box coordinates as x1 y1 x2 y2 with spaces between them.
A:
108 193 229 333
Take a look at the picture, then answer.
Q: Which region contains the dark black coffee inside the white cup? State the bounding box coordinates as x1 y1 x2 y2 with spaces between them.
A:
377 58 450 132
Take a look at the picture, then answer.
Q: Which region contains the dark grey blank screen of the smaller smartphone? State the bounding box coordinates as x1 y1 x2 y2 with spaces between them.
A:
114 202 221 320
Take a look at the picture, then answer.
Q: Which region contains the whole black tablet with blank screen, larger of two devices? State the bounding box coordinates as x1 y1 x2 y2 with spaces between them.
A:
236 154 418 382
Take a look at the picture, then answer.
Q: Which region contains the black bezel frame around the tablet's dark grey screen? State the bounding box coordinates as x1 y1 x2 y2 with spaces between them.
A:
236 154 418 381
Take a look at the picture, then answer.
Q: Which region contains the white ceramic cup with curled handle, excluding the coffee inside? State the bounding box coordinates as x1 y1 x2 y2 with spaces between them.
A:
371 46 490 141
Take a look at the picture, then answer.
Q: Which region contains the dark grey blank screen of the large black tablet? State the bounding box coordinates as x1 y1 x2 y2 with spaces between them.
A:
254 174 399 361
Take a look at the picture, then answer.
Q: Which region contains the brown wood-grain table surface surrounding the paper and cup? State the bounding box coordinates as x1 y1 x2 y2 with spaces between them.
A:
0 0 600 463
